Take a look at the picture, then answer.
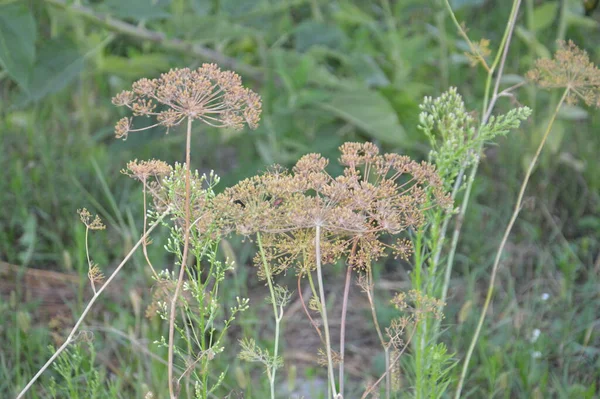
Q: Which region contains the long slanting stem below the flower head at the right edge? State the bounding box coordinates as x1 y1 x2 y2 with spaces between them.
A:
454 88 569 399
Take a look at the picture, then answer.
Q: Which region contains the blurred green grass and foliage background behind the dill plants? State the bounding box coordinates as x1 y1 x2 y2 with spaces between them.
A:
0 0 600 398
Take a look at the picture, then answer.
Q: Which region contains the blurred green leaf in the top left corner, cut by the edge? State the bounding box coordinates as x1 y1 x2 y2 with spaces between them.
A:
0 2 37 91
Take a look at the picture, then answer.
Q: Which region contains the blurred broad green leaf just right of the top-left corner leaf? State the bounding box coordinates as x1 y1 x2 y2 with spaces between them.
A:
23 40 84 101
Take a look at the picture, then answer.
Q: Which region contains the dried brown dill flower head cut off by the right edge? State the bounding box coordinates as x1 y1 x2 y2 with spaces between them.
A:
527 40 600 107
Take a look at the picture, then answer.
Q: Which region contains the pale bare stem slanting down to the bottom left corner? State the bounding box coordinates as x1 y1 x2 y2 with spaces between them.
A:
17 209 170 399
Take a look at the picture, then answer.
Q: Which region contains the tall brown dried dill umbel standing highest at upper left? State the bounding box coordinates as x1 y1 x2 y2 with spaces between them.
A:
112 64 261 138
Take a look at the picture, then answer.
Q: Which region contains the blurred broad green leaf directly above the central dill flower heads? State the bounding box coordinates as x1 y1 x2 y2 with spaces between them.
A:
321 88 407 145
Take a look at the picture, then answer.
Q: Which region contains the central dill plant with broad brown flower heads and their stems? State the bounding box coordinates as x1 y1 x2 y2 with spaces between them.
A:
213 143 451 398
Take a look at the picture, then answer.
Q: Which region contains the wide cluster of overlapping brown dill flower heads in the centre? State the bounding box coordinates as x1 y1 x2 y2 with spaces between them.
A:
214 143 452 278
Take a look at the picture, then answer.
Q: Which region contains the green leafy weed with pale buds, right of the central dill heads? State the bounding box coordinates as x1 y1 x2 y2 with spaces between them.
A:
411 88 531 398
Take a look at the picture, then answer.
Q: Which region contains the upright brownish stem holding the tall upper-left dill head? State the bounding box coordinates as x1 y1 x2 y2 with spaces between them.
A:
167 118 192 399
